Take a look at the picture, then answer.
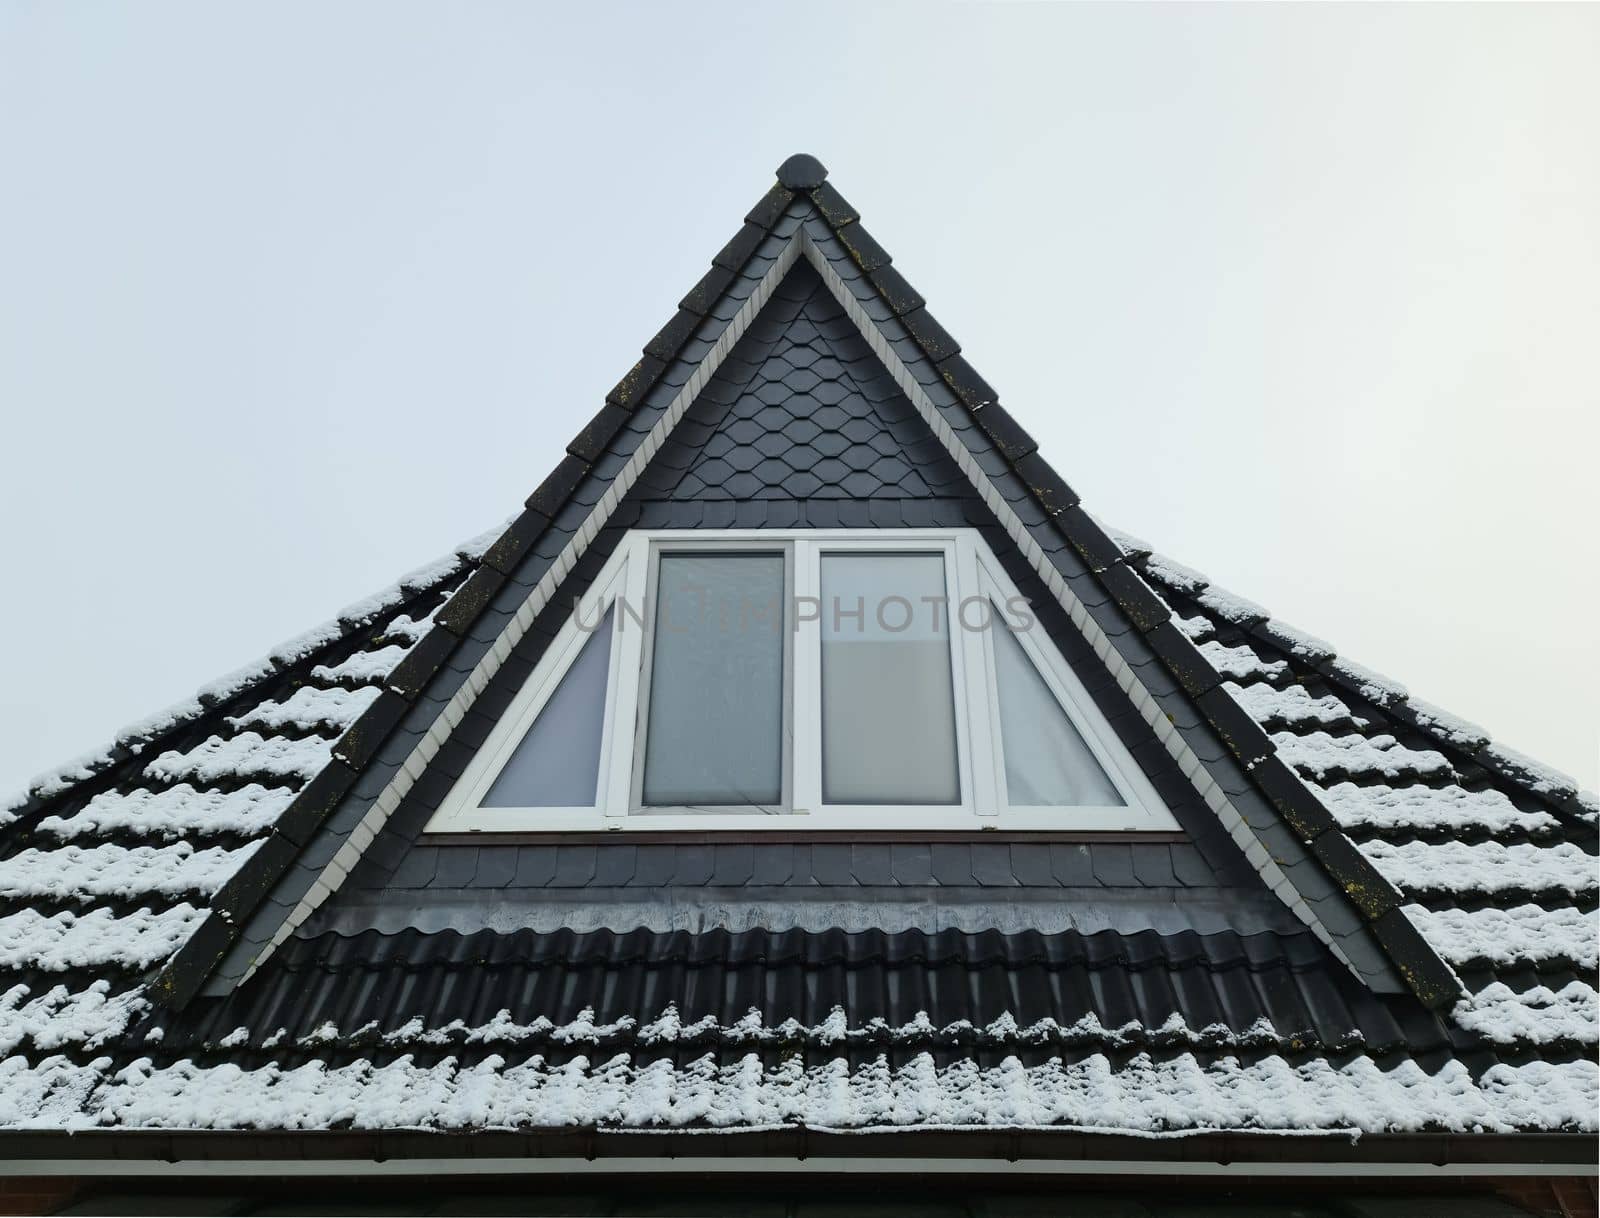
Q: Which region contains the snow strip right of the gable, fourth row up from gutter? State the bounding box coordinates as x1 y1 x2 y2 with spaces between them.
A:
1362 842 1600 896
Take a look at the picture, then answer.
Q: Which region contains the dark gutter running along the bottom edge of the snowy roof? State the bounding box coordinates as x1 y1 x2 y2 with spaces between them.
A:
0 1125 1600 1178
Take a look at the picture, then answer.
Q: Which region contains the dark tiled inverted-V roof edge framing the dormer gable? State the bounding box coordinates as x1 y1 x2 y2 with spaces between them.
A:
3 157 1484 1005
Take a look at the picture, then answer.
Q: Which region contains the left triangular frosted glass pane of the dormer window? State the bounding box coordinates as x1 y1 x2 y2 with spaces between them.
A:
483 610 611 808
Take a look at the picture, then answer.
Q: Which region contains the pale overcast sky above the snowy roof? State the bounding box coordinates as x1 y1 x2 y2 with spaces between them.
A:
0 2 1600 789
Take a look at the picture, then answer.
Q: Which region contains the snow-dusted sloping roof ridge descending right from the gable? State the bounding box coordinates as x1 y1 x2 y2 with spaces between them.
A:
1126 530 1600 824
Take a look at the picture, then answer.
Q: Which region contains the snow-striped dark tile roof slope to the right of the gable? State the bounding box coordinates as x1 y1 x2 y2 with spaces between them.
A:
1142 531 1600 1045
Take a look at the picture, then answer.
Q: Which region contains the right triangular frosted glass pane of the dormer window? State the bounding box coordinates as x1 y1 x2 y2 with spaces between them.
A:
994 610 1123 808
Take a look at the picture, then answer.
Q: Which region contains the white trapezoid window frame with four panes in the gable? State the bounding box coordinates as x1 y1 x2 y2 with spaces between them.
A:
427 528 1178 834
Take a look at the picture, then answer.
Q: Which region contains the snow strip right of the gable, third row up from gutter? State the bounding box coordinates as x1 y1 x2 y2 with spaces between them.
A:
1405 904 1600 970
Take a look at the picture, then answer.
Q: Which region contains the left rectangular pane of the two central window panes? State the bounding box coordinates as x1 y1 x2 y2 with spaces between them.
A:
643 554 784 807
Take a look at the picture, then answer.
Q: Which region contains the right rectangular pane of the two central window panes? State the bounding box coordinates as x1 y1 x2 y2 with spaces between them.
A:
821 554 962 803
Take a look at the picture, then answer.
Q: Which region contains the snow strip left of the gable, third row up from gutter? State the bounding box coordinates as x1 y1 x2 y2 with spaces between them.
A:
0 903 205 973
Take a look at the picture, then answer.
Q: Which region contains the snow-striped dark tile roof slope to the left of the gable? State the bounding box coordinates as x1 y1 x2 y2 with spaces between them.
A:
0 538 483 1075
